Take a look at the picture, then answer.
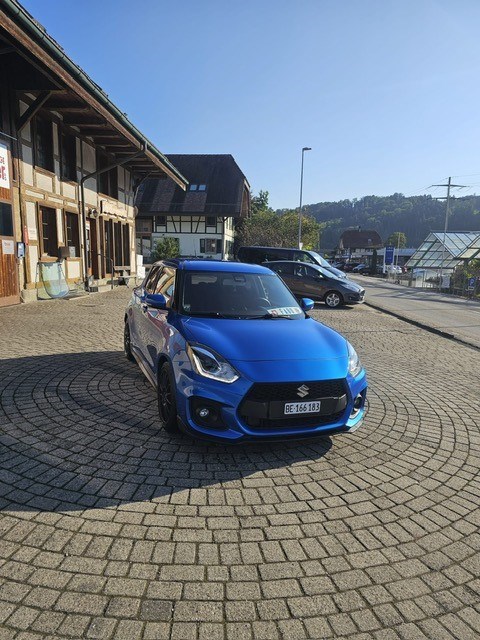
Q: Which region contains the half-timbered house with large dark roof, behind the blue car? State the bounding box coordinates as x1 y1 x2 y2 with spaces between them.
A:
135 154 250 262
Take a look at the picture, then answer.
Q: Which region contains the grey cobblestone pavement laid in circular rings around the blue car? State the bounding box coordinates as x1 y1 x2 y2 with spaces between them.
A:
0 288 480 640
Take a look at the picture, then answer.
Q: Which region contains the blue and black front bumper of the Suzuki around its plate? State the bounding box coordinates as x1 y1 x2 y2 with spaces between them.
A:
177 370 367 443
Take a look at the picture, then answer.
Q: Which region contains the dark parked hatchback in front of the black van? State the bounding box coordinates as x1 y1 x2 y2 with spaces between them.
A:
265 261 365 308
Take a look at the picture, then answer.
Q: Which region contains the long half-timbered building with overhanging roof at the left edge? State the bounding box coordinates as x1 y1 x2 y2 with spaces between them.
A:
0 0 187 305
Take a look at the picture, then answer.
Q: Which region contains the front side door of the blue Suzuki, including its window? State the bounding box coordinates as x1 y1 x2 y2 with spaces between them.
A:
143 265 177 375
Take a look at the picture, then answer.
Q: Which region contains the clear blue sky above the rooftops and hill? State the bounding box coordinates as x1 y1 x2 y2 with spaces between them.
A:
23 0 480 208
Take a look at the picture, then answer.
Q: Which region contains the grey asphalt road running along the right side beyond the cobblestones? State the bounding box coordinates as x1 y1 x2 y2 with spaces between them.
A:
352 276 480 347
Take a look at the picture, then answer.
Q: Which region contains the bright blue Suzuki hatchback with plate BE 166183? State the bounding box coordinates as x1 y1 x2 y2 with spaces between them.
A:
124 260 367 443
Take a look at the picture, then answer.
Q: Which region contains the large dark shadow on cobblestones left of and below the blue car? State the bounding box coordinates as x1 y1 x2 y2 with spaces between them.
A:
0 351 332 511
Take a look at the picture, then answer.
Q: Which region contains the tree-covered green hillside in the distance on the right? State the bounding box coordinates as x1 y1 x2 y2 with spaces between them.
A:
279 193 480 250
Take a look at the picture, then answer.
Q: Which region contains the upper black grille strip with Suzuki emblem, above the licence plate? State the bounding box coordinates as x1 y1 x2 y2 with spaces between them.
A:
245 379 347 402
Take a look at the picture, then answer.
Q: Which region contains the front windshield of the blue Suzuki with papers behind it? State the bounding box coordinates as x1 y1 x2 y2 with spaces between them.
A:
180 271 305 320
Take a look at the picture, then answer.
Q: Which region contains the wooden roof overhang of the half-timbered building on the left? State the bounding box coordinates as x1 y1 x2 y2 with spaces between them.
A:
0 0 188 189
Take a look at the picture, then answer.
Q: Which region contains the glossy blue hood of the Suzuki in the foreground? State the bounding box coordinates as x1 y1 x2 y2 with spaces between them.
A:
184 318 348 377
